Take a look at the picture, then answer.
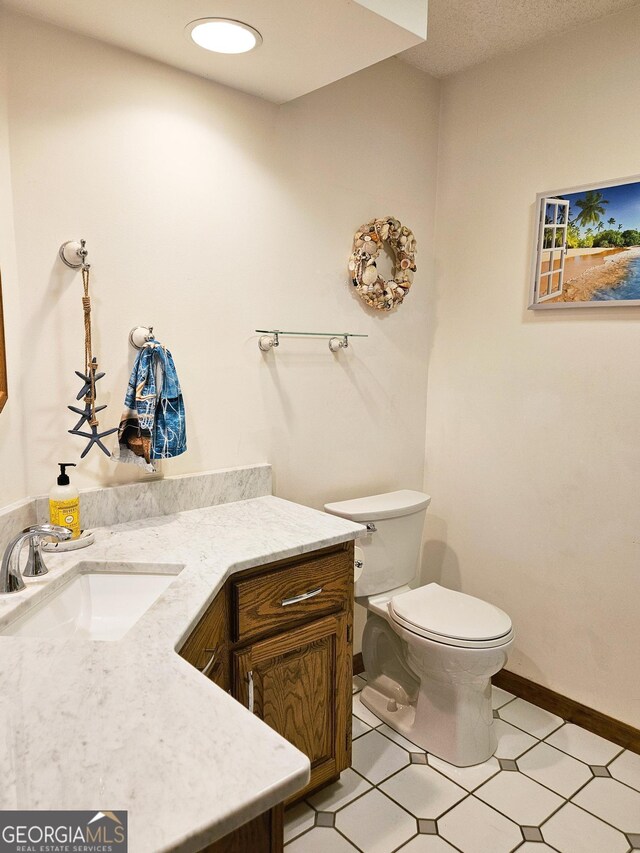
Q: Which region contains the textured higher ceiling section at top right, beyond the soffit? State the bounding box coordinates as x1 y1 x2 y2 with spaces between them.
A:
400 0 639 77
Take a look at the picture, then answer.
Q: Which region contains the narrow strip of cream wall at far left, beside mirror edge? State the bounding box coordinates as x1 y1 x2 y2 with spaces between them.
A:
0 18 26 507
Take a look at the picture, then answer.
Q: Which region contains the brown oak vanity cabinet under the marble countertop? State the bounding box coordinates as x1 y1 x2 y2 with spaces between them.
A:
180 542 353 851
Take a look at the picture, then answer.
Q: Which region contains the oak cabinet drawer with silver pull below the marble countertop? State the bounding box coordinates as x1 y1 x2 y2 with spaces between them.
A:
231 548 353 642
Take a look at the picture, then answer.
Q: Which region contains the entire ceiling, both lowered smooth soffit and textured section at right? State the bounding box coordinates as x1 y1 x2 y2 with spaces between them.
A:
0 0 640 97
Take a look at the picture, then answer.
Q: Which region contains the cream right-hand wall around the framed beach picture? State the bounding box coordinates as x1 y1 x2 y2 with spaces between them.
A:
423 8 640 725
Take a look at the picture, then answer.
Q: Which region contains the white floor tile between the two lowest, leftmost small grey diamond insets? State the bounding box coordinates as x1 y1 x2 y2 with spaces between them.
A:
327 784 417 853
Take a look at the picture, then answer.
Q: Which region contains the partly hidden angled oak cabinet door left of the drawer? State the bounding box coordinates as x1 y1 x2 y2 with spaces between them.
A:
180 592 230 690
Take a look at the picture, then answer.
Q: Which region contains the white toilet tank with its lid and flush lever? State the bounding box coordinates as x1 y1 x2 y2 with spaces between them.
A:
324 489 431 598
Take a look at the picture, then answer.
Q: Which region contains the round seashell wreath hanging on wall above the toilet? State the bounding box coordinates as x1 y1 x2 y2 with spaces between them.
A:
349 216 416 311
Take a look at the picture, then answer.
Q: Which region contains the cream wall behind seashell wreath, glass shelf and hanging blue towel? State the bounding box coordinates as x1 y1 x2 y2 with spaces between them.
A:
0 16 439 506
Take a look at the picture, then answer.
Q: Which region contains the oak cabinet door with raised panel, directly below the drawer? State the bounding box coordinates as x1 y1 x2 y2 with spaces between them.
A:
233 612 351 799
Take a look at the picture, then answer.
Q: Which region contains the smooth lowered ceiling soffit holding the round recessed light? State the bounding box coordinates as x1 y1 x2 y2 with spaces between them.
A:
0 0 427 103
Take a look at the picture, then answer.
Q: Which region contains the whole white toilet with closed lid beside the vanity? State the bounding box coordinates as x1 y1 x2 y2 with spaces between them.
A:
325 490 513 767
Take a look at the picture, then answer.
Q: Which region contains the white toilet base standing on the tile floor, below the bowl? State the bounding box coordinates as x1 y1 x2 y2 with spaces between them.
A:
361 678 497 767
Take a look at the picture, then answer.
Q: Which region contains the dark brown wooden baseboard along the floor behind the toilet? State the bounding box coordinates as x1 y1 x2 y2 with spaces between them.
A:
353 653 640 753
